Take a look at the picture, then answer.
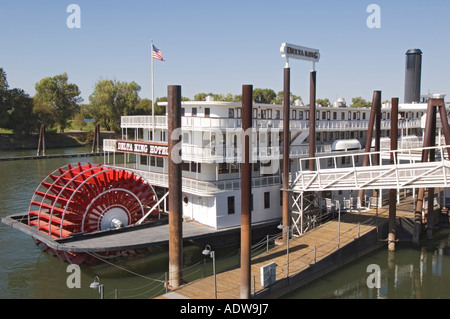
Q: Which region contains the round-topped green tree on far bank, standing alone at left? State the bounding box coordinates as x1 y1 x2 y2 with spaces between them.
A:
34 73 82 132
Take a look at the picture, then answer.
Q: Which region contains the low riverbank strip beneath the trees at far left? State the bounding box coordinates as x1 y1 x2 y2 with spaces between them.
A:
0 131 118 151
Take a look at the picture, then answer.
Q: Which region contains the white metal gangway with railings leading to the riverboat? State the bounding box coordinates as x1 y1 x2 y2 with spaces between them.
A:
290 145 450 192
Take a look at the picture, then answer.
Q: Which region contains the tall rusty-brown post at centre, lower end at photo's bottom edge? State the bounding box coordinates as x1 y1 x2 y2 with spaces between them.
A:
241 85 253 299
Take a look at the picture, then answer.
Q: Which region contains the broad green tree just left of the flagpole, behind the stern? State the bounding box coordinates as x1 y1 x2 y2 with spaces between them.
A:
87 80 141 132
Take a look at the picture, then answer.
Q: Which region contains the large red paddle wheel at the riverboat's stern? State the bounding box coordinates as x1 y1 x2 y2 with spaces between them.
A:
28 163 158 260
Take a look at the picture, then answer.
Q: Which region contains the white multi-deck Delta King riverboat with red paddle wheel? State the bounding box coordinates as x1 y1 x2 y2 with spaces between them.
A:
3 96 446 262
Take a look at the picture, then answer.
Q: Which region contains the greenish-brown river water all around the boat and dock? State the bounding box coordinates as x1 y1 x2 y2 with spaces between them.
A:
0 148 450 299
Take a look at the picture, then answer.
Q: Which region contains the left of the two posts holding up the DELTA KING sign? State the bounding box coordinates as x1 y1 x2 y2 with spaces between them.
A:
282 66 291 240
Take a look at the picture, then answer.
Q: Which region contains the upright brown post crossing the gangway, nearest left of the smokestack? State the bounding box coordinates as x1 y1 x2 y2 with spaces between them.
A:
388 98 398 251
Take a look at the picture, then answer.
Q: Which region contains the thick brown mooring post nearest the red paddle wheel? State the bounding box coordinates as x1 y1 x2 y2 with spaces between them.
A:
167 85 183 288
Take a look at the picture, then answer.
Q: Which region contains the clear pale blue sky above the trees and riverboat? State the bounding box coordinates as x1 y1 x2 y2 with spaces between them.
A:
0 0 450 102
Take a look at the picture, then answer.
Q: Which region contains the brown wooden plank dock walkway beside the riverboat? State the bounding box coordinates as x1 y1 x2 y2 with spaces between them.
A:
159 201 413 299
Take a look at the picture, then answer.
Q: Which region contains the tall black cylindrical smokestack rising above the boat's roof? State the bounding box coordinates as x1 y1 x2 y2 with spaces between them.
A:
404 49 422 103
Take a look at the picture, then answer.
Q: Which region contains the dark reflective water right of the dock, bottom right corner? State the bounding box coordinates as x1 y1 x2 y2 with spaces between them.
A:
285 229 450 299
